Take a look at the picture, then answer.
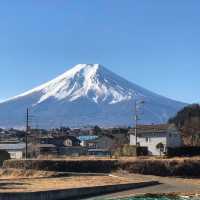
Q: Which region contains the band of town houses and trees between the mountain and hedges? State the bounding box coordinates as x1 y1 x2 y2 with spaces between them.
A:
0 104 200 159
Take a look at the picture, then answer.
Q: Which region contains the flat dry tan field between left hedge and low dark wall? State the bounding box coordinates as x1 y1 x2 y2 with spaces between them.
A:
0 175 142 193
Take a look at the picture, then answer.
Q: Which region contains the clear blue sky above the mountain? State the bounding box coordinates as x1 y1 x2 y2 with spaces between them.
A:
0 0 200 103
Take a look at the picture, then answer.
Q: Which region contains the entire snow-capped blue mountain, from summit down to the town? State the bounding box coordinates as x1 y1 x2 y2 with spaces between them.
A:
0 64 186 128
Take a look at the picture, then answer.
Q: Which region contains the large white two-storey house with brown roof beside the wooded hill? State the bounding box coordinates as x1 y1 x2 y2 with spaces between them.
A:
130 124 182 155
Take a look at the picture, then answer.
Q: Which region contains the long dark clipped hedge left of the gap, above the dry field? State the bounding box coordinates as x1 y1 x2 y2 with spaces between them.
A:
3 160 118 173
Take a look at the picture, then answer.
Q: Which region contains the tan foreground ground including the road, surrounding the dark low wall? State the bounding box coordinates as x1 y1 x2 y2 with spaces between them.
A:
0 170 200 200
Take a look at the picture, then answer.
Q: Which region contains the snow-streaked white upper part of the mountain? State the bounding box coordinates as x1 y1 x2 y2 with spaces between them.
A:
7 64 134 106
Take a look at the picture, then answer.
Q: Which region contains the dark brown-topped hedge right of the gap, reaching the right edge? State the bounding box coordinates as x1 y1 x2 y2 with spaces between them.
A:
119 158 200 177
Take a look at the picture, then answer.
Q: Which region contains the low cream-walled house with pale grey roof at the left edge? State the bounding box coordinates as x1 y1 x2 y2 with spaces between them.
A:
0 143 26 159
